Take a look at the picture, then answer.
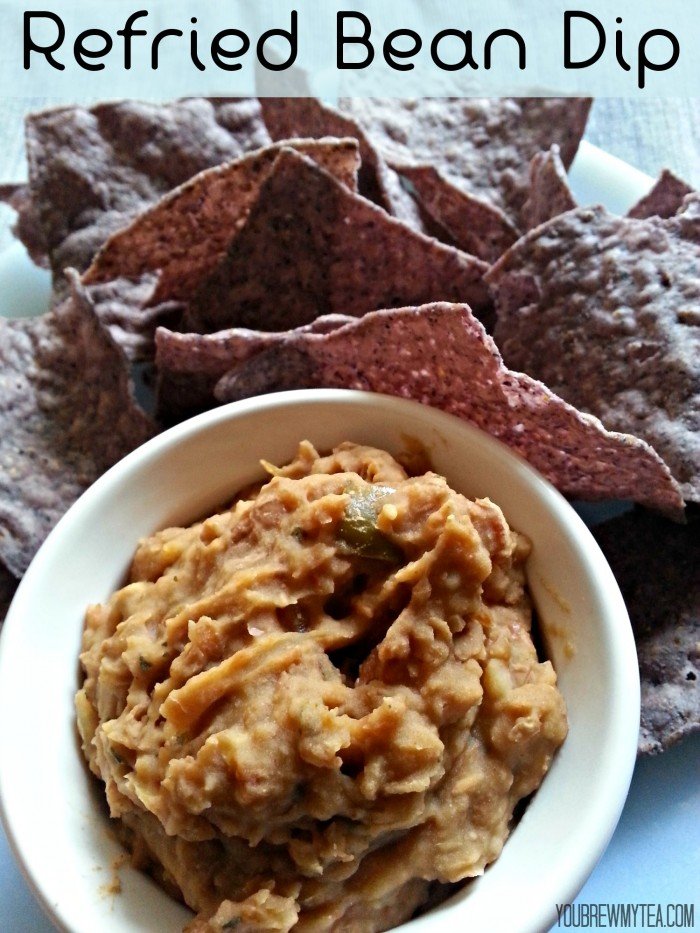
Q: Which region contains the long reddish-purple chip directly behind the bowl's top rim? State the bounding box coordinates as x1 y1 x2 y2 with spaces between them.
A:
202 303 683 518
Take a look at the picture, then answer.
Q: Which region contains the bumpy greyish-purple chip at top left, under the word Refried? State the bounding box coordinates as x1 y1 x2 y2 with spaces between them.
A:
27 98 269 294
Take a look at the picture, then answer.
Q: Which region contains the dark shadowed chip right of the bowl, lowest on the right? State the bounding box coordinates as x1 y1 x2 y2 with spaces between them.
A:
593 510 700 753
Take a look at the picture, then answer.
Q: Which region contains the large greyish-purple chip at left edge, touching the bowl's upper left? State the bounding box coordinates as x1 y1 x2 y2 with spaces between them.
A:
0 275 153 577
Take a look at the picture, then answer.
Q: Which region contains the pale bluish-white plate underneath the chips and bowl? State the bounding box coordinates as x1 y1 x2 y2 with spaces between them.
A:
0 142 700 933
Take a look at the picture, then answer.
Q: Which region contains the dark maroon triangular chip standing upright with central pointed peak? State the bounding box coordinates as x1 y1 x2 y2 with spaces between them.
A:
186 149 488 332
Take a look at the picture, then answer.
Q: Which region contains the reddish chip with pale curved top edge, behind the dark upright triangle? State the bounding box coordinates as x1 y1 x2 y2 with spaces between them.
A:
83 139 359 360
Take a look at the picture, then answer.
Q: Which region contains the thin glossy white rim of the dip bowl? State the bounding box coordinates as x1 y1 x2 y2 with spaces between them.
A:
0 389 640 933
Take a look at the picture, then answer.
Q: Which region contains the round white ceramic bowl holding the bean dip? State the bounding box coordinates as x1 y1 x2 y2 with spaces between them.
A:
0 390 639 933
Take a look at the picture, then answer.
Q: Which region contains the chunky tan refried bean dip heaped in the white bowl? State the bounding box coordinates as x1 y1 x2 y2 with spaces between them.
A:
76 442 567 933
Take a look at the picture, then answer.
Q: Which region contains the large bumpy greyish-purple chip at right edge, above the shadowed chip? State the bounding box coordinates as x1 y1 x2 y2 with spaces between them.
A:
487 207 700 501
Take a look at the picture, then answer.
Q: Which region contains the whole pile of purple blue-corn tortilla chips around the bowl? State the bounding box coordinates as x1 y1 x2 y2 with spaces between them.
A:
0 98 700 751
